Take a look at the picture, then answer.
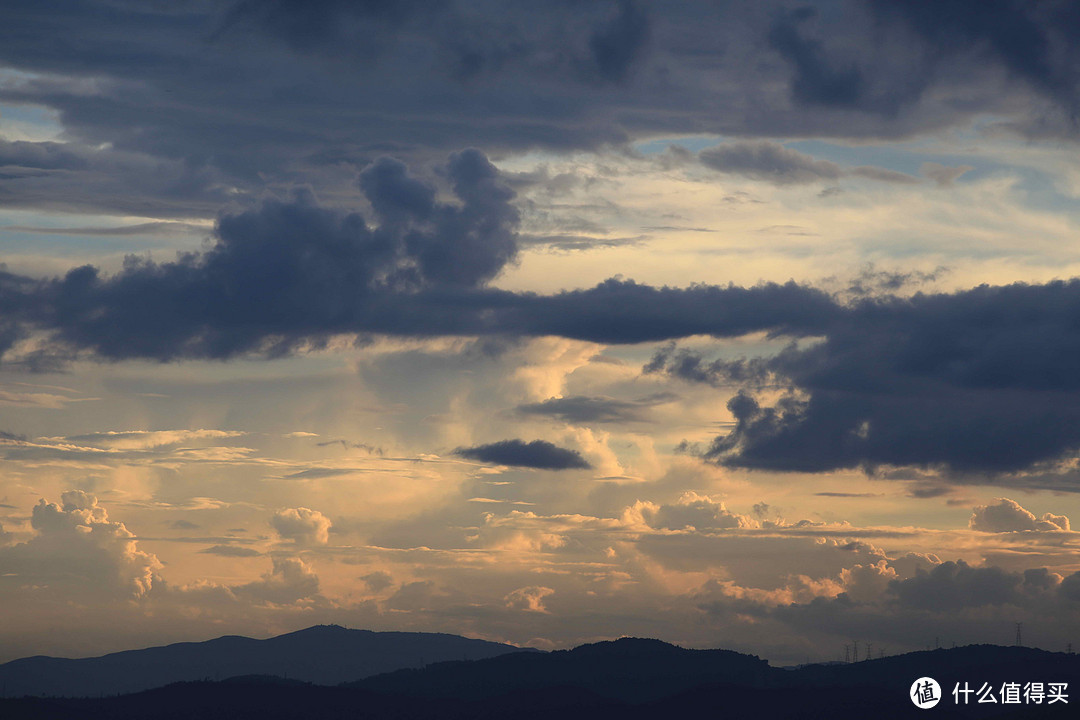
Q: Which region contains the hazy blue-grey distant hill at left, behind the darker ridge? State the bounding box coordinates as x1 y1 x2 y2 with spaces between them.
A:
0 625 535 697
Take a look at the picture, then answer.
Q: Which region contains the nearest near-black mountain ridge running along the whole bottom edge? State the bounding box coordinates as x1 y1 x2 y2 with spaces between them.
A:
0 639 1080 720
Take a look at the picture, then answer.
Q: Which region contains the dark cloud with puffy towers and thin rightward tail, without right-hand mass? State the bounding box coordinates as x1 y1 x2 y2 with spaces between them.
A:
0 162 839 360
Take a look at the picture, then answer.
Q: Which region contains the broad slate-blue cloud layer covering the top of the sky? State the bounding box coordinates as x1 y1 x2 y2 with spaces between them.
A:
0 0 1080 217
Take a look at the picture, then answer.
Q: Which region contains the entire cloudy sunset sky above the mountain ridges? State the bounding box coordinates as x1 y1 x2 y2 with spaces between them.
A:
0 0 1080 664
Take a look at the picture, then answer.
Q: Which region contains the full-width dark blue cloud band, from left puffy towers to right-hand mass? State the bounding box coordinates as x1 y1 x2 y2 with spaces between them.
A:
10 157 1080 481
